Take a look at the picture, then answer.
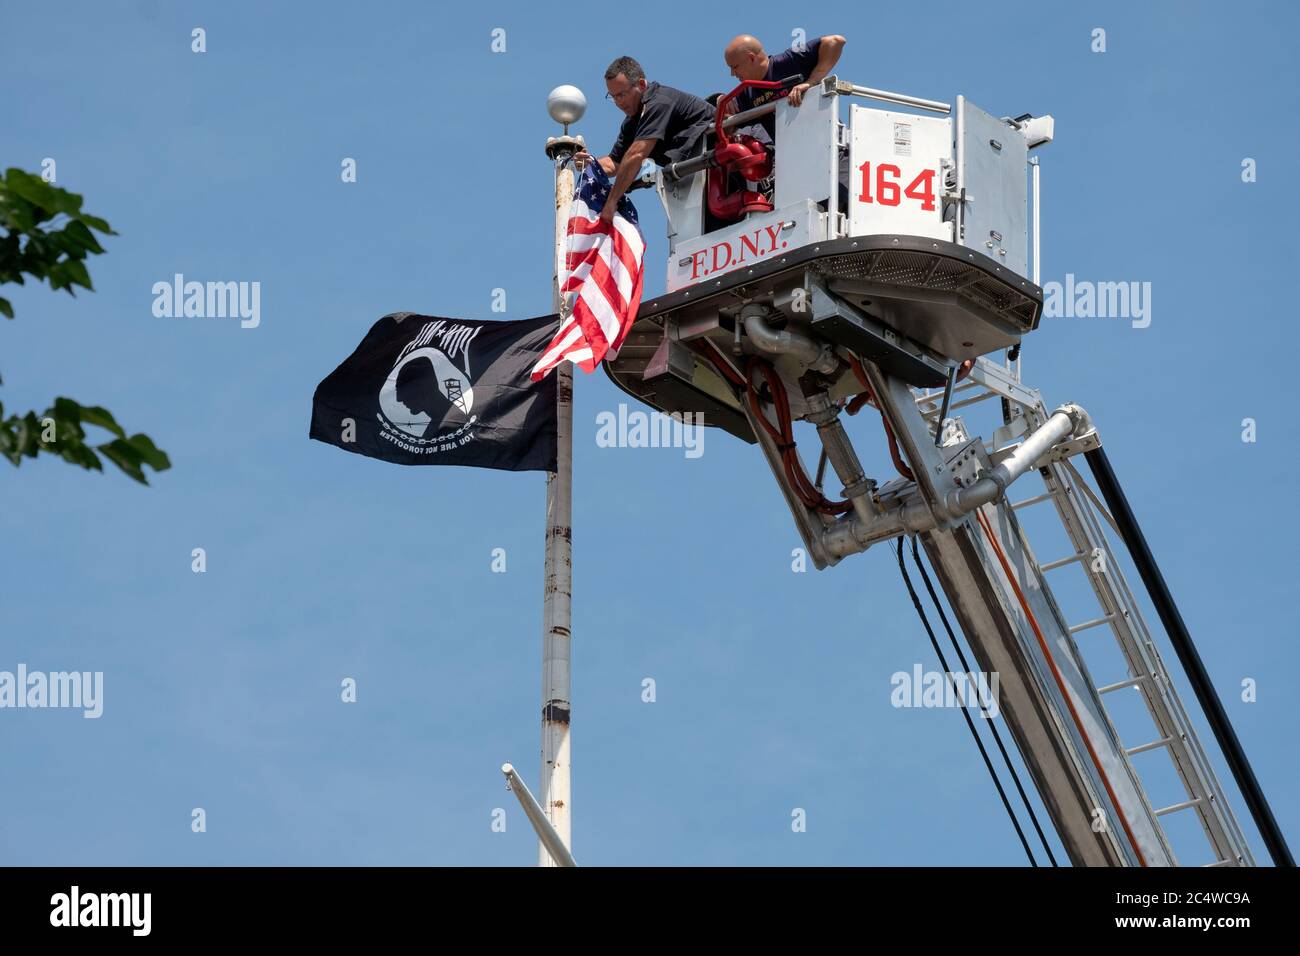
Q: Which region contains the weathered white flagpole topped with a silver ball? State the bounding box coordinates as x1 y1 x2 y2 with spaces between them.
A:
537 86 586 866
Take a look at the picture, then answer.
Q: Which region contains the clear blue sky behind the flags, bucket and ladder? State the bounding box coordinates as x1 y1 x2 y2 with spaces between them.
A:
0 0 1300 865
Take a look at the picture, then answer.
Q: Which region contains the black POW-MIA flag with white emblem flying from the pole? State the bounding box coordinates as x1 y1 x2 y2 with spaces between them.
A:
311 312 559 471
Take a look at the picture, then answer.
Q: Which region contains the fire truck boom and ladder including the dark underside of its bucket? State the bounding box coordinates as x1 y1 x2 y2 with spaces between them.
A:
607 243 1294 866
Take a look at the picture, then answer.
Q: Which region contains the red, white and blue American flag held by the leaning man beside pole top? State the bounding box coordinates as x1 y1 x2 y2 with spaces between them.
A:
532 161 646 381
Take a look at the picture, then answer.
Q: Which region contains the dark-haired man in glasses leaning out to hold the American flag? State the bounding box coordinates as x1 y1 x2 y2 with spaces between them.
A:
575 56 715 222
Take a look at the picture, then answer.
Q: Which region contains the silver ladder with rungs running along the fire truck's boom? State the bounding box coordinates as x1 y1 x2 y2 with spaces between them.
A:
914 359 1255 866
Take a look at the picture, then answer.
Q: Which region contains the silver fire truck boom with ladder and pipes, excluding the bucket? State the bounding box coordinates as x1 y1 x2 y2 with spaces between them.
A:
722 323 1294 866
